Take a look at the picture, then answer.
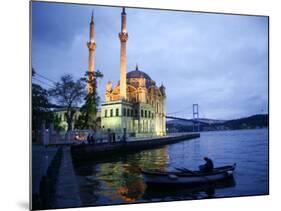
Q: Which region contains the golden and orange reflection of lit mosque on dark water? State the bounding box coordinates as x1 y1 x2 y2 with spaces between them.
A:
75 147 168 205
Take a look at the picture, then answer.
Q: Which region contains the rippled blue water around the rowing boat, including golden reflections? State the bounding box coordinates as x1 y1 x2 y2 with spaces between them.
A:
71 129 269 206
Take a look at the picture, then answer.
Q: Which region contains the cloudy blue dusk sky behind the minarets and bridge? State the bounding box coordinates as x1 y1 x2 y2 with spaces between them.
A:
32 2 268 120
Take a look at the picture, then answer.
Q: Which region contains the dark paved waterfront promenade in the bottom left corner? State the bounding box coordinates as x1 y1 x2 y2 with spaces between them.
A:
32 144 80 209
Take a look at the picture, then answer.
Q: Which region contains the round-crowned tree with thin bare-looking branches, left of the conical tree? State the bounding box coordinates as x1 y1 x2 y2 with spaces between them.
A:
49 74 85 131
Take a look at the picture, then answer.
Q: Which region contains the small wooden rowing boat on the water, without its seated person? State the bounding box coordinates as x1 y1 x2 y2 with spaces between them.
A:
141 164 236 185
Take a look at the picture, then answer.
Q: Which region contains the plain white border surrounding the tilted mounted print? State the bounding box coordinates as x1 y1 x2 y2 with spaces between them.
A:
0 0 281 211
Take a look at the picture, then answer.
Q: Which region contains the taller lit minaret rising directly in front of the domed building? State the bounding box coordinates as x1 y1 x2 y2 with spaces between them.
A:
119 7 128 100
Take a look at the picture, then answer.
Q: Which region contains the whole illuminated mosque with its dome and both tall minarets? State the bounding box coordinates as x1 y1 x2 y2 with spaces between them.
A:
87 8 166 137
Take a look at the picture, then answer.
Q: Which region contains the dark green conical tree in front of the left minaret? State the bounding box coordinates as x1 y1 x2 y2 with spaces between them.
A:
76 70 103 129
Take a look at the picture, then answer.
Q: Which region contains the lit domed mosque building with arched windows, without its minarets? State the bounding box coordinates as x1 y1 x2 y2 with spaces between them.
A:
101 66 166 136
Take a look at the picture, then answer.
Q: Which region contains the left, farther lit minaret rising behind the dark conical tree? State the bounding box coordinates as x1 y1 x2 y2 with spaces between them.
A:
87 11 96 94
